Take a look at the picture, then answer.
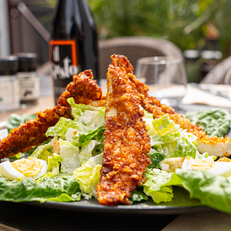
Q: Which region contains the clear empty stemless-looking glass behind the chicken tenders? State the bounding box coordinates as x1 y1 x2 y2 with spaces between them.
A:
135 56 187 109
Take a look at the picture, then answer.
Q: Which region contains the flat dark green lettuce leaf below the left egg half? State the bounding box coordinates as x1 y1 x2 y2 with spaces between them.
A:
0 175 80 203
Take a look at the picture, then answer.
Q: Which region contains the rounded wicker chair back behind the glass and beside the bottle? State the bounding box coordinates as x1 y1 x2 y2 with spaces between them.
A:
99 37 183 79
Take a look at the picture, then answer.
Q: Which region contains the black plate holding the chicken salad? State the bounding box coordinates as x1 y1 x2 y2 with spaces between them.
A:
0 105 228 215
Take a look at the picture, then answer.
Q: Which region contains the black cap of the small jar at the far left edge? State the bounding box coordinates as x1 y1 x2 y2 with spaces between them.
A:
0 55 18 75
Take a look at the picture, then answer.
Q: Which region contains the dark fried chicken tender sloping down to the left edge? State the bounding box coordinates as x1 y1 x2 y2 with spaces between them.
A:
0 70 102 159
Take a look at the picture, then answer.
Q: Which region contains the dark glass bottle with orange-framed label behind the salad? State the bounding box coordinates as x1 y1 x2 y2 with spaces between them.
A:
49 0 99 103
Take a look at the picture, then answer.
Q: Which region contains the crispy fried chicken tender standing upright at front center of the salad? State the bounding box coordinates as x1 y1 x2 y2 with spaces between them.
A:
96 63 151 205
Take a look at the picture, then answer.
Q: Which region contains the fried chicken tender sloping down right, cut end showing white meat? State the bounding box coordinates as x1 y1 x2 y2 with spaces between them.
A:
108 55 231 157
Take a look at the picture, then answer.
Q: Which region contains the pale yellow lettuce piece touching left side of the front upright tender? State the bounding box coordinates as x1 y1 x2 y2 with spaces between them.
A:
73 154 103 196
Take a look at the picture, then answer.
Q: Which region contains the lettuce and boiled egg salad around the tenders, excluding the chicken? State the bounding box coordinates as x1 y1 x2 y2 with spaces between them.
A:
0 98 231 213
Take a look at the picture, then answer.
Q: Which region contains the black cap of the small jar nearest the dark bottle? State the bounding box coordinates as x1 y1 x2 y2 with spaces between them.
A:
14 53 38 72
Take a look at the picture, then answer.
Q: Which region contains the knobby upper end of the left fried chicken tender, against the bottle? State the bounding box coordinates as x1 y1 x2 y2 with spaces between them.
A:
57 70 102 107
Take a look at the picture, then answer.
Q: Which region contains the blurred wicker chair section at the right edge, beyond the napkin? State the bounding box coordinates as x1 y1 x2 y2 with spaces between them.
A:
201 56 231 84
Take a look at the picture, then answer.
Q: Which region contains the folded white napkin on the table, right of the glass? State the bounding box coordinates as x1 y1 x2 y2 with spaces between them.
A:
182 84 231 108
